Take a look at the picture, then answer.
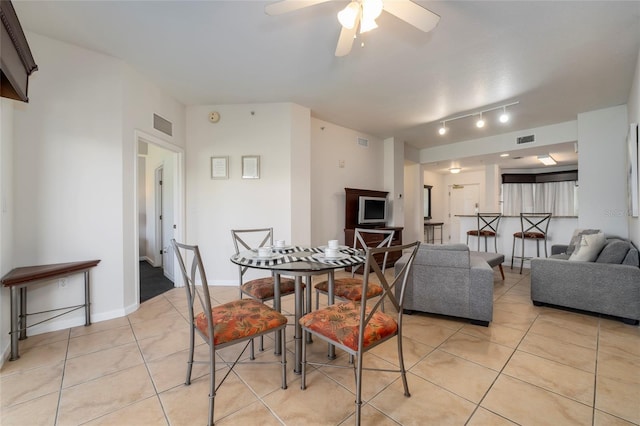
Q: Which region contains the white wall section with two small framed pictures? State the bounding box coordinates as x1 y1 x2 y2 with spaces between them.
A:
186 103 310 284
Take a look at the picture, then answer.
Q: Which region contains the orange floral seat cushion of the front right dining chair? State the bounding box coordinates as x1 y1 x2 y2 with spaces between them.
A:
300 302 398 351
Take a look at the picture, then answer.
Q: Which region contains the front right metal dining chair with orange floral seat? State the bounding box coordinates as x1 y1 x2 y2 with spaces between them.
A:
299 241 420 425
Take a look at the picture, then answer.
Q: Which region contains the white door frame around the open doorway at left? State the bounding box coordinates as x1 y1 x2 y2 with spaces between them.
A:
132 130 186 303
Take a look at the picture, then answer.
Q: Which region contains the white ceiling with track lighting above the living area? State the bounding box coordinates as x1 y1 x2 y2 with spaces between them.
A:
13 0 640 171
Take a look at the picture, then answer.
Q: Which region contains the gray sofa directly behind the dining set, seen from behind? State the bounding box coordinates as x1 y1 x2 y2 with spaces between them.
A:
395 244 493 326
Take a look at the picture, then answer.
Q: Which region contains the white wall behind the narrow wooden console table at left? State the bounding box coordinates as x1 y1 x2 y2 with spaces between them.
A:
2 33 184 350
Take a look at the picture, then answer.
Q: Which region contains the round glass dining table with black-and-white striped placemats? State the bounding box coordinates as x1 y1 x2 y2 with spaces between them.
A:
231 246 366 374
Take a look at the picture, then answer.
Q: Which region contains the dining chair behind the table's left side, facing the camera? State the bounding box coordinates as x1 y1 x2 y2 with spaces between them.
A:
231 228 296 351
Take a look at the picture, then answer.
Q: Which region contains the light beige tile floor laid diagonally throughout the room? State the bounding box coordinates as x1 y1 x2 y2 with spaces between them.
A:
0 268 640 426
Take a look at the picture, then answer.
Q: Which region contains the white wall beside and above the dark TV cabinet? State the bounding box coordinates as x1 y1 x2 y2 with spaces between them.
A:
311 118 389 244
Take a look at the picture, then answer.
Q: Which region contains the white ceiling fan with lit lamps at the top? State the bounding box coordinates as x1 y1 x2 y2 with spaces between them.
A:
264 0 440 56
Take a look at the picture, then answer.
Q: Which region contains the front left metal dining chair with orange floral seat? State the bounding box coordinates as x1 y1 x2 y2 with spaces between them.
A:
171 240 287 425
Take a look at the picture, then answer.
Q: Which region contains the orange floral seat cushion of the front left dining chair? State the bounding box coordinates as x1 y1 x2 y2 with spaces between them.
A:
195 299 287 345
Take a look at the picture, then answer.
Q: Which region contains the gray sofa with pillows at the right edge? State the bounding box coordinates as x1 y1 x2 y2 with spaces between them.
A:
531 237 640 325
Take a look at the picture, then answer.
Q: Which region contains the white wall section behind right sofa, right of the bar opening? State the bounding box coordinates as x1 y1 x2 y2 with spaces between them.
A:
578 105 629 237
